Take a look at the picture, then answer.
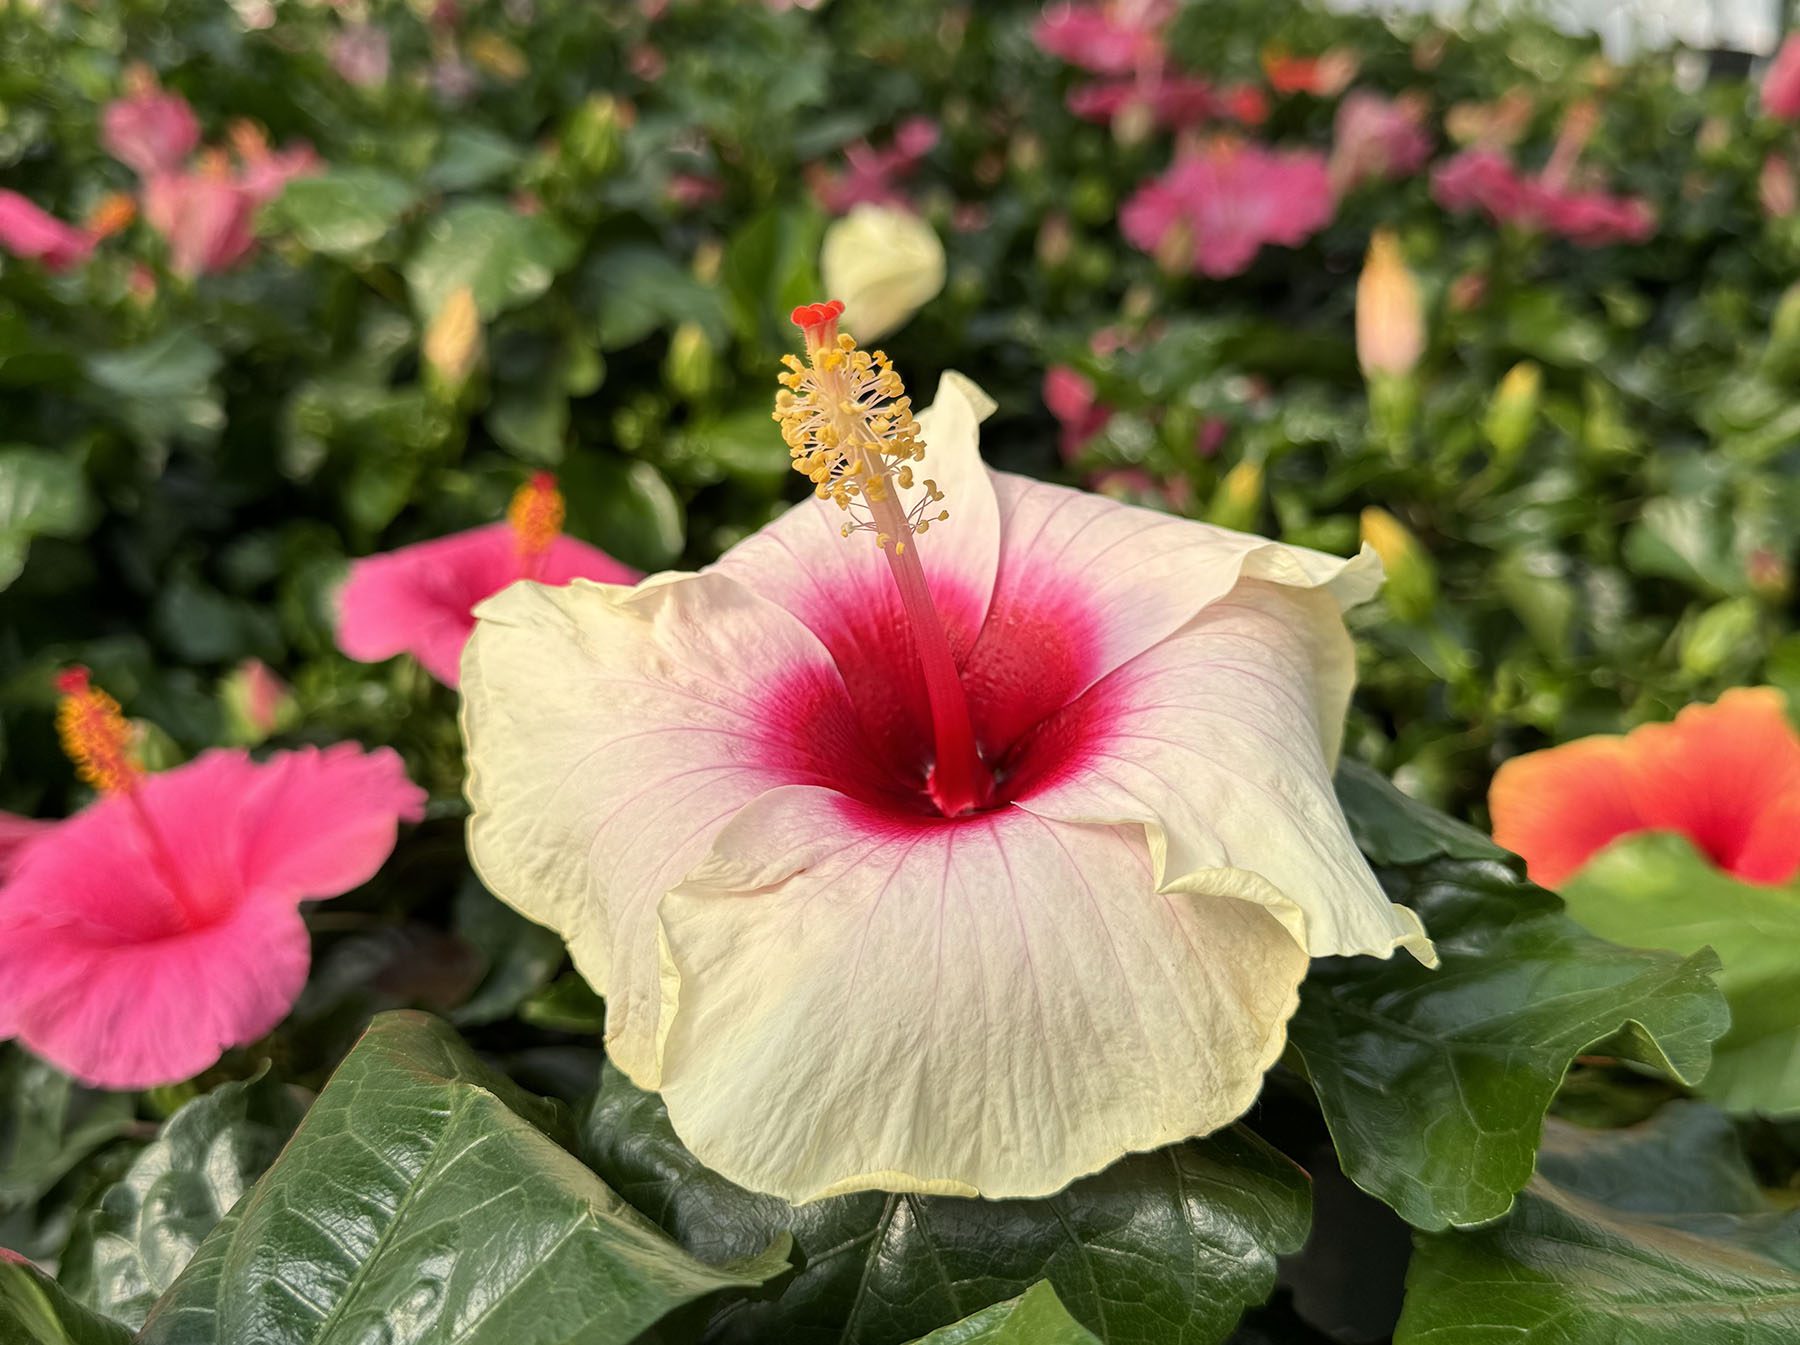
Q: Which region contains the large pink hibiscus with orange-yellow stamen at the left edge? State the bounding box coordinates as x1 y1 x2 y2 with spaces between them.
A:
0 668 425 1089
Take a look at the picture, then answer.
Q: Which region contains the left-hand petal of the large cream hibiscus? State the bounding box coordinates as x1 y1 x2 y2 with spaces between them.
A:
463 573 859 1088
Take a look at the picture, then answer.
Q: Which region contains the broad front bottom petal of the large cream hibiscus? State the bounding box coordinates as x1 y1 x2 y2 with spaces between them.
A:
662 787 1305 1201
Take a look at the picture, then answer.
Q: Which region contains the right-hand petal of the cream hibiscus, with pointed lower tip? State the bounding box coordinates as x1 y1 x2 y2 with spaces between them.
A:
1013 574 1436 963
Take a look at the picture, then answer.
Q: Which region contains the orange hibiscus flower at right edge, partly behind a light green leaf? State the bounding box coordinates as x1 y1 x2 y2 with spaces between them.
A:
1489 686 1800 888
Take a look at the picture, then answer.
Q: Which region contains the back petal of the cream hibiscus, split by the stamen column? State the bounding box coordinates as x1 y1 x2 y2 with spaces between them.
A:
711 373 1001 785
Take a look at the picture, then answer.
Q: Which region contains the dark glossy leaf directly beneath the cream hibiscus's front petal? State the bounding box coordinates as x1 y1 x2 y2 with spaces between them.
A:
583 1066 1310 1345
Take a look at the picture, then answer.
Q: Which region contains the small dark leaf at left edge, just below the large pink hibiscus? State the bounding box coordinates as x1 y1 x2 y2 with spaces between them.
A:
0 1048 135 1210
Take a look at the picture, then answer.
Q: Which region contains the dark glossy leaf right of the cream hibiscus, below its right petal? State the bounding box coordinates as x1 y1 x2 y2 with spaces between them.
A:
1289 767 1726 1228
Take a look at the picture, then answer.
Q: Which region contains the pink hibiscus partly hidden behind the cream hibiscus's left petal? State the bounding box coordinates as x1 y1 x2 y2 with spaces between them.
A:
337 472 641 686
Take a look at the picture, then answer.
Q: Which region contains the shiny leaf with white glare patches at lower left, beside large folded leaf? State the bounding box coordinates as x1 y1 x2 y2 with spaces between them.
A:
61 1073 306 1329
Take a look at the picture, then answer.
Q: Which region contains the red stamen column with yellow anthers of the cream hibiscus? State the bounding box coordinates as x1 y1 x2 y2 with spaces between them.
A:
776 299 994 817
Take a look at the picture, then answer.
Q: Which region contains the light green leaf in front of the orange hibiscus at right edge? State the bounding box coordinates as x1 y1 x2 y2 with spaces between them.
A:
1562 834 1800 1113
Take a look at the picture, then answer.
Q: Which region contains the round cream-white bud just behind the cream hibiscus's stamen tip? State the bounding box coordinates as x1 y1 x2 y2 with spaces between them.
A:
819 203 945 342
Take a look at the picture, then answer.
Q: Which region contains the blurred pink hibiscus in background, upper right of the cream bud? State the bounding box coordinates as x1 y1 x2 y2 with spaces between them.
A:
1120 139 1334 277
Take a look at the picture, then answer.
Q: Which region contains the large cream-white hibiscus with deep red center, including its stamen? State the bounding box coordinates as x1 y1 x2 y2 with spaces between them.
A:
463 304 1433 1201
